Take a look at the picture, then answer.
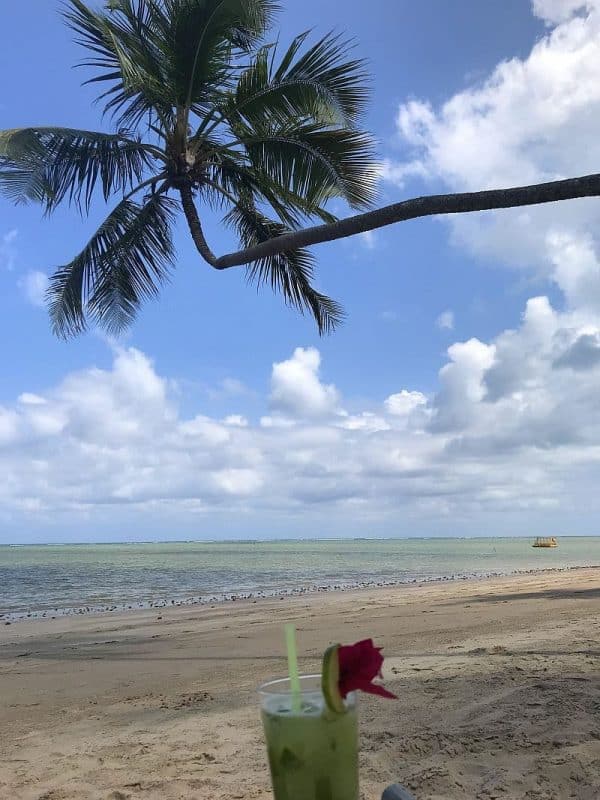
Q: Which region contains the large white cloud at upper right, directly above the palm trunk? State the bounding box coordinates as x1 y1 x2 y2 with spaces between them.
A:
397 11 600 190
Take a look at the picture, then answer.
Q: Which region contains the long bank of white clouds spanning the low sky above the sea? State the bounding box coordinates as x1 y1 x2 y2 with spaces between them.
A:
0 334 600 535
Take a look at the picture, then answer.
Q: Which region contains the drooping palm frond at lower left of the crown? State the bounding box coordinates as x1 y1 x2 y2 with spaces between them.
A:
47 194 174 338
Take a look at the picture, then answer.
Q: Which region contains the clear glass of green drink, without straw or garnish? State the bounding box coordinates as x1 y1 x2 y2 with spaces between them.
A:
259 675 358 800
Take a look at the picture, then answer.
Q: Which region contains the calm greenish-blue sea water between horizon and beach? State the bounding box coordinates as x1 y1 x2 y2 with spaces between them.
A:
0 537 600 617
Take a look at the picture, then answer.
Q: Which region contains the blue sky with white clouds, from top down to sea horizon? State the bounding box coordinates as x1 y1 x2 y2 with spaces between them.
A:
0 0 600 543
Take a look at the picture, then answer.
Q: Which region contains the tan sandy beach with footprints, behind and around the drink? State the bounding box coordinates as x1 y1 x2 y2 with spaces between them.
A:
0 569 600 800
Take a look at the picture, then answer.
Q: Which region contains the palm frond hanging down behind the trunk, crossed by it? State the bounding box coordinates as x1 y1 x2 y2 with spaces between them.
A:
225 202 344 335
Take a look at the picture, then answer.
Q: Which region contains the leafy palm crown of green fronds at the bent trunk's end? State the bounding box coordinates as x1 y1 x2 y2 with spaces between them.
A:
0 0 377 337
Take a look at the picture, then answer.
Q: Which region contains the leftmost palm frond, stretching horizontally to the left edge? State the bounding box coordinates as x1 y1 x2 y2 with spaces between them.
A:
0 127 157 211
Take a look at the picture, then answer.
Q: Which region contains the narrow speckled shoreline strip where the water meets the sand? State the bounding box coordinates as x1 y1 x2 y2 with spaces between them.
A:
0 564 600 625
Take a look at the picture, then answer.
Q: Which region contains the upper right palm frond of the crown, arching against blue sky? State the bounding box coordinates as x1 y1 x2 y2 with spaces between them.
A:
226 32 369 127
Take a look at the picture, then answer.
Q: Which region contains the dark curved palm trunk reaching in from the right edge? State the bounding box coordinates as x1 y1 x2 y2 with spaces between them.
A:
212 174 600 269
